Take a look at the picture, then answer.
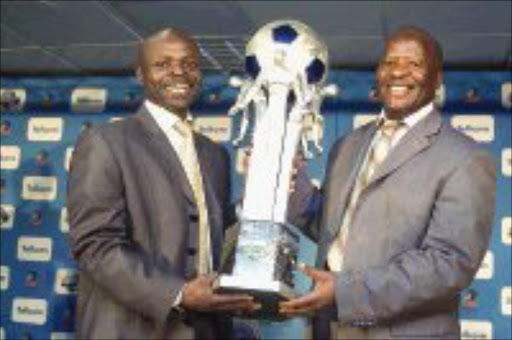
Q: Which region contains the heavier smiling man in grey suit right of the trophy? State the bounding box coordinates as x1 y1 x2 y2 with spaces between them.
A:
281 27 496 339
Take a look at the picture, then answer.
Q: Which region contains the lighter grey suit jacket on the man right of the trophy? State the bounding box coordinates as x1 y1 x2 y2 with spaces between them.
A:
292 111 496 338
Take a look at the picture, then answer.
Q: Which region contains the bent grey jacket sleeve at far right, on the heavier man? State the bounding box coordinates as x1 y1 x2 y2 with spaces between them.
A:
336 148 496 324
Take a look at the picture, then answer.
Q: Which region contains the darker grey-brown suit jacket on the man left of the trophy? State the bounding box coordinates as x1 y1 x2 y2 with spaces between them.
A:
68 107 235 339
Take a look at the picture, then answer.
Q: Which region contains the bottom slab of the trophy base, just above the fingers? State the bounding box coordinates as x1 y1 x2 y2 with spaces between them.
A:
214 275 297 321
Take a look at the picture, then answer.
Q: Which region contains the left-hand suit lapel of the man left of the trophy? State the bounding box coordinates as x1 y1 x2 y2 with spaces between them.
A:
135 106 195 204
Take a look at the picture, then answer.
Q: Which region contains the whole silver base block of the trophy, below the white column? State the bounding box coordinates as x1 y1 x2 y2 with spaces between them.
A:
214 221 299 320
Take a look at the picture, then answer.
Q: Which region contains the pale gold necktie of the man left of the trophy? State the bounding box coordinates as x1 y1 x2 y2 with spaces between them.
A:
174 120 212 274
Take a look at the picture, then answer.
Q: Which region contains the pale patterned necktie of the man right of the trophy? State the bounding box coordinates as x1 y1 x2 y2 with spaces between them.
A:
327 120 405 271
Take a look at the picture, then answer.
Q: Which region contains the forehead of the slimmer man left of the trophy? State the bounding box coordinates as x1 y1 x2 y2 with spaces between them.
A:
141 35 199 58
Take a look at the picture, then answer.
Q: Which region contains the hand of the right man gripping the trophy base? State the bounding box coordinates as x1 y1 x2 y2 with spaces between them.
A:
279 266 336 316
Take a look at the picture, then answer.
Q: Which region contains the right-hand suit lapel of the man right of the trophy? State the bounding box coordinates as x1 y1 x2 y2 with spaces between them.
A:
367 111 442 187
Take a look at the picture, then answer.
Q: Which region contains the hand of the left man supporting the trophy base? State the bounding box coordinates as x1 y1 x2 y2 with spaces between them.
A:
181 274 255 312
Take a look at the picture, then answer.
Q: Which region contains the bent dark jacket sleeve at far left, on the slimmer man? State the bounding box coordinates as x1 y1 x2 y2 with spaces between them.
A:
67 129 184 323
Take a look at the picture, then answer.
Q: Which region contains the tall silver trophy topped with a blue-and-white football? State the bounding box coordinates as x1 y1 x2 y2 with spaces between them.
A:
215 20 327 319
